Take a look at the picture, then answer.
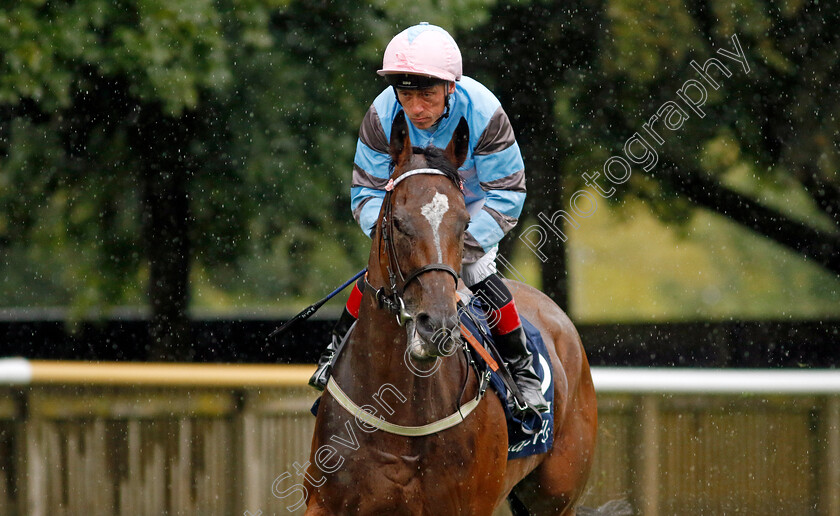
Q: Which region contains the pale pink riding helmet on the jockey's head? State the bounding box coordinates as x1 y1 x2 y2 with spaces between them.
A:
376 22 462 81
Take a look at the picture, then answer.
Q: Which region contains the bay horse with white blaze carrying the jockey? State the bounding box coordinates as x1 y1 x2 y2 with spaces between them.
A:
305 111 597 516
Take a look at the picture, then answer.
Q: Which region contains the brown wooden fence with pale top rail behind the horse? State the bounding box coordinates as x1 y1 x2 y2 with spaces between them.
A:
0 360 840 516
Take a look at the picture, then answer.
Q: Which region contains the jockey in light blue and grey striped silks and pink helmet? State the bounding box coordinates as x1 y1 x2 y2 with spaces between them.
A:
309 23 548 412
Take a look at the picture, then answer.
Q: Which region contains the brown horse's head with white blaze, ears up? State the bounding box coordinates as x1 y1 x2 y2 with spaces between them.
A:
374 112 470 360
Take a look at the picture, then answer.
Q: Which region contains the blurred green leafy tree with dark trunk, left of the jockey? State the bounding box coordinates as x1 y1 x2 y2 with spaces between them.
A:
0 0 498 359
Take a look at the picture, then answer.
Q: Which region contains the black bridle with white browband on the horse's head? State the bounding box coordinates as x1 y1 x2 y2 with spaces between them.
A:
365 168 459 326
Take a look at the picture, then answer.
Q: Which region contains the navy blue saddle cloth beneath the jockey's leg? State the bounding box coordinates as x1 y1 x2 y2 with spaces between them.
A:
311 298 554 459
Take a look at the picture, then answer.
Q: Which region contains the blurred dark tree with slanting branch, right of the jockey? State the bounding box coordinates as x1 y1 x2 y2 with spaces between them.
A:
466 0 840 306
